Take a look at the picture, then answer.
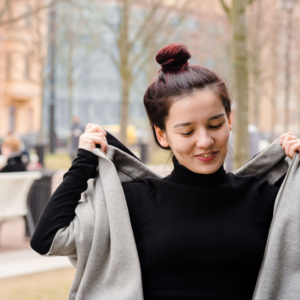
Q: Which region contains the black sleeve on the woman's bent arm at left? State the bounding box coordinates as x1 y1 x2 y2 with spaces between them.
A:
30 149 98 254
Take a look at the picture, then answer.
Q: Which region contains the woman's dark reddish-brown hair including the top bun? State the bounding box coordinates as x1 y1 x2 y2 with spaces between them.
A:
144 44 232 149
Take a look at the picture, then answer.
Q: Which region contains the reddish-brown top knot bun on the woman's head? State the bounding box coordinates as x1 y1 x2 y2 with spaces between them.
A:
156 44 191 73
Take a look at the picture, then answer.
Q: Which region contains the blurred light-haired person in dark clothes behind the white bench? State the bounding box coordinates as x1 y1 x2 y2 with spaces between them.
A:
0 135 26 172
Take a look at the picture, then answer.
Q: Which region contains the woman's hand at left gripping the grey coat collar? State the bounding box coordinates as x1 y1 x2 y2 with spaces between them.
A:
79 123 107 153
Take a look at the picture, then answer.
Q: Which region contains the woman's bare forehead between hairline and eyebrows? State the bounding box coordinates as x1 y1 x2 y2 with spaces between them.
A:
168 90 225 122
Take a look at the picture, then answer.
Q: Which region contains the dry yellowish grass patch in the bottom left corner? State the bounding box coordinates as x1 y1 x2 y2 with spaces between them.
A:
0 268 75 300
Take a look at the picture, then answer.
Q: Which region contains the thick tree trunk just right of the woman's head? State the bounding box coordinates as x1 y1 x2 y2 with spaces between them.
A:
231 0 250 170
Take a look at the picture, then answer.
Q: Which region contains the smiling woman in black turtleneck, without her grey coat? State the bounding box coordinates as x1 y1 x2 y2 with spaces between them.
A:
31 44 300 299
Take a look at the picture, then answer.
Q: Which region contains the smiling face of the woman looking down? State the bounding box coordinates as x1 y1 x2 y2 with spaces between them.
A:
155 90 231 174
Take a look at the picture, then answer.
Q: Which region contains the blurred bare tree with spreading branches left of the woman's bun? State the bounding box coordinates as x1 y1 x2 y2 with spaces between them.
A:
86 0 194 143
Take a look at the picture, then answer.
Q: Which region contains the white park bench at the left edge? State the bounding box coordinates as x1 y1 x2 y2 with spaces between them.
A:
0 171 42 239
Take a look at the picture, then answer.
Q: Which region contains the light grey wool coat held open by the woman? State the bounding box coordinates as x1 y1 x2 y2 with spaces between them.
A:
46 140 300 300
